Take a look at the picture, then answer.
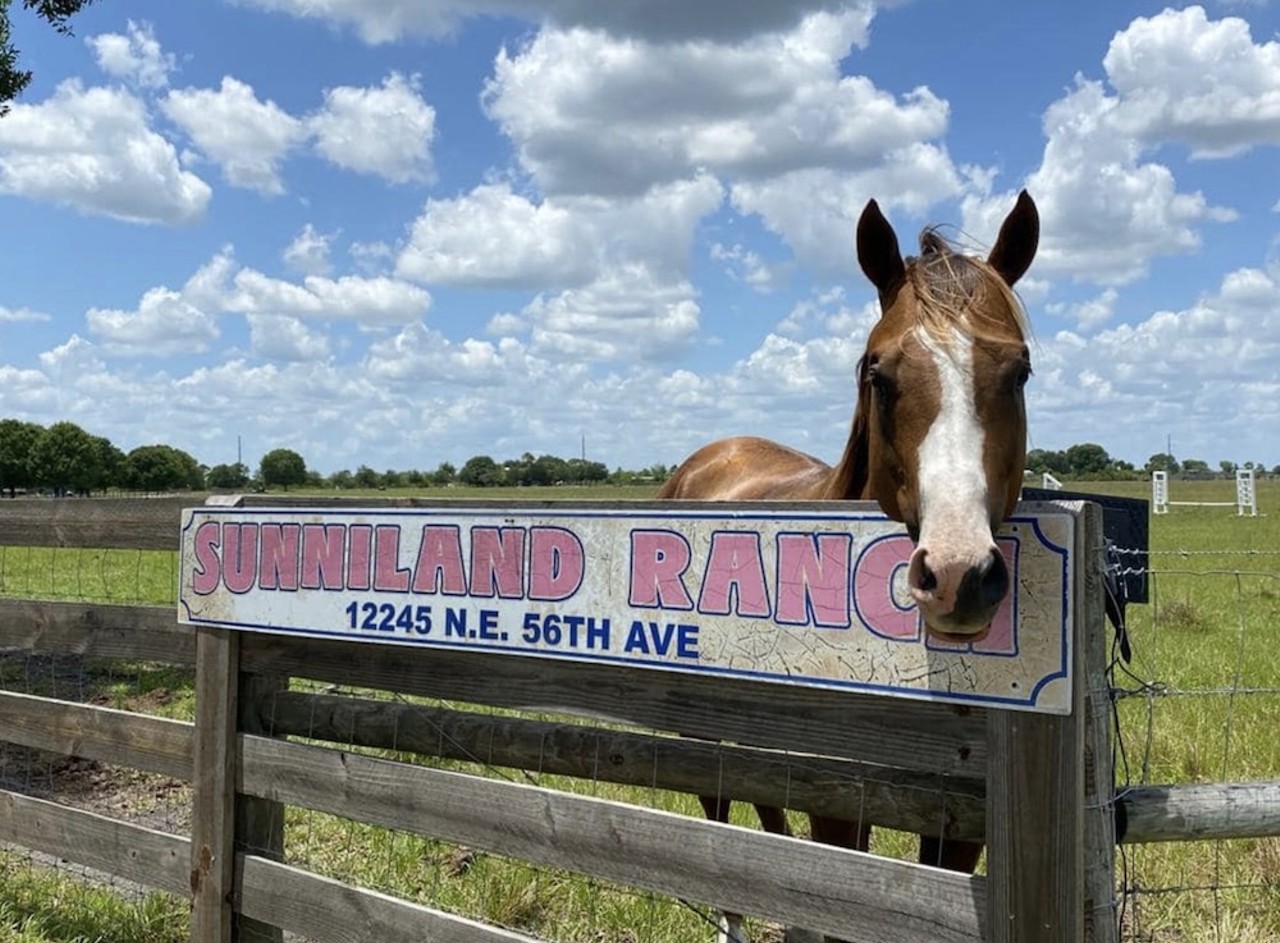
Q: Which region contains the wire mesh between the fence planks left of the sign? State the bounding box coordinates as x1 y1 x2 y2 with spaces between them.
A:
0 546 193 943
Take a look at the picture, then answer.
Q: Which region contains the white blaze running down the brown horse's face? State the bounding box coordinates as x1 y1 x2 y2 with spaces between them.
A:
911 328 995 621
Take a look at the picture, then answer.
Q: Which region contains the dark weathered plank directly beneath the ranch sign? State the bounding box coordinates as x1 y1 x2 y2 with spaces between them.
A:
241 632 987 778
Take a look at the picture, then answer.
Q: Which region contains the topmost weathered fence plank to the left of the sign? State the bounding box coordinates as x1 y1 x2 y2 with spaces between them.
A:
0 495 194 550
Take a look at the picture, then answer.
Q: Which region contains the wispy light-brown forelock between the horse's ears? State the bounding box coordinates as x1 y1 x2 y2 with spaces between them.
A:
906 226 1030 344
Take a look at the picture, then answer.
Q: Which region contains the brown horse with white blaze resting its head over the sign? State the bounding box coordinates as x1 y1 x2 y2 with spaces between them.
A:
659 191 1039 935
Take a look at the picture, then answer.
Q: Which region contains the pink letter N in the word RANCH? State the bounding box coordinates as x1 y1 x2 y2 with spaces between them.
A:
774 534 854 628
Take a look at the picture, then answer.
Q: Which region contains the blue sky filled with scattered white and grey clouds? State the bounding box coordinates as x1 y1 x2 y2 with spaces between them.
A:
0 0 1280 472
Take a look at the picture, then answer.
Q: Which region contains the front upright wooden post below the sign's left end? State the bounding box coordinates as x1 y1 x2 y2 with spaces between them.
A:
191 627 239 943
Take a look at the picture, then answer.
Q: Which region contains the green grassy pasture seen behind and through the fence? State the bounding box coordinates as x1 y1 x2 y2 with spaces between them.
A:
0 481 1280 943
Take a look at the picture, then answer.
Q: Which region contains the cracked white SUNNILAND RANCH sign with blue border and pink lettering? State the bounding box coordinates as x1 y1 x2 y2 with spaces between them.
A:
178 504 1074 714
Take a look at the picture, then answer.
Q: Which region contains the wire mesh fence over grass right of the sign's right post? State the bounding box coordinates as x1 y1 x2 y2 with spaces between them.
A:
1112 532 1280 943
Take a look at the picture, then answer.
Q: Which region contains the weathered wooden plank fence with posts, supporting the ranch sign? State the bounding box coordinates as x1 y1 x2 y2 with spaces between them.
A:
0 499 1192 943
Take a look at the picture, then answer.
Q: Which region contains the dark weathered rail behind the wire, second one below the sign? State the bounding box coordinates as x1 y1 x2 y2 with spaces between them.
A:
264 692 986 841
